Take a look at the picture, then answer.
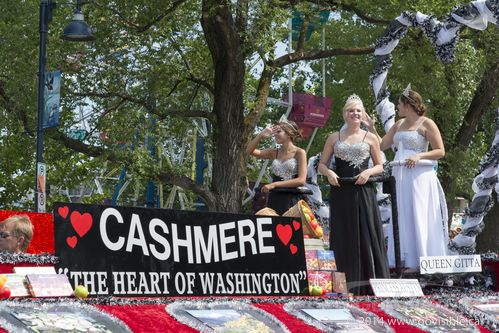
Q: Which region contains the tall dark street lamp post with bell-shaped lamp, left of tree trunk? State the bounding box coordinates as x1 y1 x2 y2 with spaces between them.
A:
35 0 95 212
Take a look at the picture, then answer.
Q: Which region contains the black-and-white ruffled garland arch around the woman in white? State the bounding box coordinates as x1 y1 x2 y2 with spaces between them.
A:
370 0 499 254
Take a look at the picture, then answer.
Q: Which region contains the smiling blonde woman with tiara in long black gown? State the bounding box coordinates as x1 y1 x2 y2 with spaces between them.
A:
319 95 389 295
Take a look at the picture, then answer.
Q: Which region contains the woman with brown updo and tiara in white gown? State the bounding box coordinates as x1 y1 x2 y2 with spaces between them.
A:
369 85 448 268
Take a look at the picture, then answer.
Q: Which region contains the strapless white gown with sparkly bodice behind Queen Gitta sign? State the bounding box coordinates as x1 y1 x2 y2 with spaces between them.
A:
388 130 448 268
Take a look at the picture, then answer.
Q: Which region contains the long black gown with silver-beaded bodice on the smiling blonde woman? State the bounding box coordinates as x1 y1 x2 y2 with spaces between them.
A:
330 135 389 295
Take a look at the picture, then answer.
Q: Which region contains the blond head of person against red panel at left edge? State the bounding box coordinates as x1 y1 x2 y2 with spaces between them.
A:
0 215 33 253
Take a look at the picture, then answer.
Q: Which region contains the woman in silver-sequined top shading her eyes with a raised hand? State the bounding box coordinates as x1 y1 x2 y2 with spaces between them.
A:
246 120 307 215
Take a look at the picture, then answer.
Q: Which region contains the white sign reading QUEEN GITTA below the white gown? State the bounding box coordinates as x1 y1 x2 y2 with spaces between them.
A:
419 254 482 274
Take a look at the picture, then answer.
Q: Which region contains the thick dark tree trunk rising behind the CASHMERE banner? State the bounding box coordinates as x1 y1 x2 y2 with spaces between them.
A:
201 0 246 213
